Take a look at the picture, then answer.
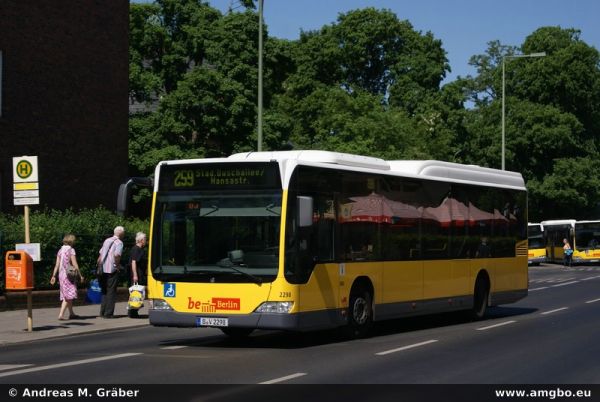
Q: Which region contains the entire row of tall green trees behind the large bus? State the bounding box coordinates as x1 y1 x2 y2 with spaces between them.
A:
129 0 600 220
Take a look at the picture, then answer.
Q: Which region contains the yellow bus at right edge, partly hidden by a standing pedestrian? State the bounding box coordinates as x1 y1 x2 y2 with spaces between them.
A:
542 219 600 264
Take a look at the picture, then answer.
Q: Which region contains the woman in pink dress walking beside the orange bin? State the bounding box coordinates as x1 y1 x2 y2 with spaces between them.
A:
50 234 83 321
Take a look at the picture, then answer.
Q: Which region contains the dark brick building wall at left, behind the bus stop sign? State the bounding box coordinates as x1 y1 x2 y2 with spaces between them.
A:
0 0 129 212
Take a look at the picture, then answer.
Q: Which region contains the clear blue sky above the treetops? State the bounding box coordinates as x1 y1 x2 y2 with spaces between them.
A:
208 0 600 82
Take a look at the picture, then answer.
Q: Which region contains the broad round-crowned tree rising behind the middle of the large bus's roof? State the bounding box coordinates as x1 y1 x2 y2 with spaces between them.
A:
265 8 454 159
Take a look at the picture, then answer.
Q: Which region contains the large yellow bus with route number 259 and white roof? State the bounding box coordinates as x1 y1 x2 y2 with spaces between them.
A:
143 151 528 336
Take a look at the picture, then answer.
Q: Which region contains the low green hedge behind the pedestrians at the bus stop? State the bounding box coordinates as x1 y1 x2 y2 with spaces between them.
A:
0 208 149 289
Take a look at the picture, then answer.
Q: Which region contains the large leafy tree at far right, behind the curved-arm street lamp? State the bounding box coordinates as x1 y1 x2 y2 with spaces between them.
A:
459 27 600 220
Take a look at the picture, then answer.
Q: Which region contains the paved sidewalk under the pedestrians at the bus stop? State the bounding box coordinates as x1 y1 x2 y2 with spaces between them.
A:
0 300 148 346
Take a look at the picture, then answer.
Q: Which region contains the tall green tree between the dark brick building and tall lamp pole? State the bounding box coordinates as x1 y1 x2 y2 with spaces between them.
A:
129 0 295 175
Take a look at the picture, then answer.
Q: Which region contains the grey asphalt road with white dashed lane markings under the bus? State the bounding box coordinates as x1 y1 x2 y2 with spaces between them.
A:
0 264 600 384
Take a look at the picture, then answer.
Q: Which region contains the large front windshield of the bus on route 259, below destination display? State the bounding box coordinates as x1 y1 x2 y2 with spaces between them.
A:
152 191 281 283
